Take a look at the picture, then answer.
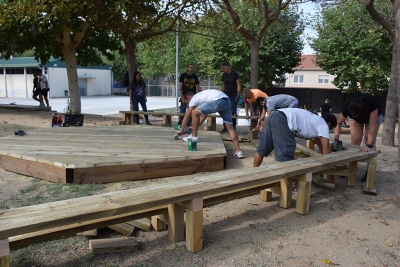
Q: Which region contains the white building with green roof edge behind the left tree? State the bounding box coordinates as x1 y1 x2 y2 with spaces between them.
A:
0 57 113 98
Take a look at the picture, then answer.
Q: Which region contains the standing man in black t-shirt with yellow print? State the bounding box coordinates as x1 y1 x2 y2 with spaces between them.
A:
178 64 201 127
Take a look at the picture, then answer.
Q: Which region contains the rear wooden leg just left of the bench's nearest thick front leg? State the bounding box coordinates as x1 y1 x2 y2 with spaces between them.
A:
168 204 185 242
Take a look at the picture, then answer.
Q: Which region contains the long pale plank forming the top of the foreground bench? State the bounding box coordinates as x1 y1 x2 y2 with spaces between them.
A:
0 152 376 241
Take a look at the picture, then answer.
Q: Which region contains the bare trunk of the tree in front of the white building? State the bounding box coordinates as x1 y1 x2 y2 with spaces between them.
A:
61 45 81 114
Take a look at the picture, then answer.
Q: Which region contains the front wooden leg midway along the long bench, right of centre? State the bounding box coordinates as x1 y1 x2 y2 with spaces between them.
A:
296 172 312 214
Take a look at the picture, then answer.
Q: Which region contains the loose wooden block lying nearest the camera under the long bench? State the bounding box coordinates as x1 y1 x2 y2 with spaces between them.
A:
89 238 139 254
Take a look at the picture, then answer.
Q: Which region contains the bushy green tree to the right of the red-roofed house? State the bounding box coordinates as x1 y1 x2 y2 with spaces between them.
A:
310 0 393 94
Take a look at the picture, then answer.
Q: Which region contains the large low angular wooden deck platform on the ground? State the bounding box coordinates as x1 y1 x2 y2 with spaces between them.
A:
0 125 226 184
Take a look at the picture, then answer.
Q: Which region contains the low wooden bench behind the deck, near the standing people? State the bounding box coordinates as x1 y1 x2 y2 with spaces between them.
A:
119 111 259 139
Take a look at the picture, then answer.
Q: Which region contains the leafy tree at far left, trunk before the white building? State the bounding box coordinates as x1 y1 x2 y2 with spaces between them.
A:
0 0 119 114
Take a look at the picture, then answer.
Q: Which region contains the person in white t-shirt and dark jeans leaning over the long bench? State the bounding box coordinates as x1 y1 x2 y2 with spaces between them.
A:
253 108 337 167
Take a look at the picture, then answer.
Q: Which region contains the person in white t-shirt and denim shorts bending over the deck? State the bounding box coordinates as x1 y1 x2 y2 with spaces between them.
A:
176 89 243 159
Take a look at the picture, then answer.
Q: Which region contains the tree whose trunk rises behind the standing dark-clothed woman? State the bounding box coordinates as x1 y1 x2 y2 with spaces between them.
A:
88 0 193 85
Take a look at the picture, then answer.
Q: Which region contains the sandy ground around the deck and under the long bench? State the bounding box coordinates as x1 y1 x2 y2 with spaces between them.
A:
0 109 400 266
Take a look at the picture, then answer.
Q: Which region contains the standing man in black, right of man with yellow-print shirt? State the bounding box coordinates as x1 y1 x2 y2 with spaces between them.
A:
221 61 241 133
